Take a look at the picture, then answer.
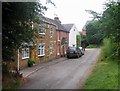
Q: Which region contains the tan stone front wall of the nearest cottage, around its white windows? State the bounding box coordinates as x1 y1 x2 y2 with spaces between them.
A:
20 23 56 69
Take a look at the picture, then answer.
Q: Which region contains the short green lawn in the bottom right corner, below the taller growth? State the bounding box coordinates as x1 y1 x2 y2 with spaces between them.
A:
83 60 118 89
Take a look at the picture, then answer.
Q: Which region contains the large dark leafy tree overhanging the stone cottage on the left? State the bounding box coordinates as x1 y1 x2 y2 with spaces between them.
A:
2 2 46 61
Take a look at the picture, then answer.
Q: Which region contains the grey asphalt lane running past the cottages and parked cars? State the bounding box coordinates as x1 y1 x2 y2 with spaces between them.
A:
21 48 100 89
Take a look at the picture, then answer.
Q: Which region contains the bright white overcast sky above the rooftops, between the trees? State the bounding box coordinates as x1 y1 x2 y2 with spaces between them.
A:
42 0 106 31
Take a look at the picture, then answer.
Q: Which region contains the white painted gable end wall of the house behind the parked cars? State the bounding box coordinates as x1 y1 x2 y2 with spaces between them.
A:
69 25 79 46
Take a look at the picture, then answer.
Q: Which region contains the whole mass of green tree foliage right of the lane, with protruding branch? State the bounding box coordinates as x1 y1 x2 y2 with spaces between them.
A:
87 1 120 58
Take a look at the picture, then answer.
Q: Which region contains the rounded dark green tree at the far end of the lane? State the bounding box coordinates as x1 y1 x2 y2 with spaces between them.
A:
86 20 104 44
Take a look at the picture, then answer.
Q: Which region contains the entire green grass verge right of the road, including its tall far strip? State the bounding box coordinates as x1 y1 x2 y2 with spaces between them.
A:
83 39 119 89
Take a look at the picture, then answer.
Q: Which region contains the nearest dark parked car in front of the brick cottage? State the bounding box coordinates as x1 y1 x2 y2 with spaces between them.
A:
66 47 82 58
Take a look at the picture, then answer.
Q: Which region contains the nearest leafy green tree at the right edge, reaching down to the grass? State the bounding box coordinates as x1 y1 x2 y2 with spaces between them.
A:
100 2 120 58
